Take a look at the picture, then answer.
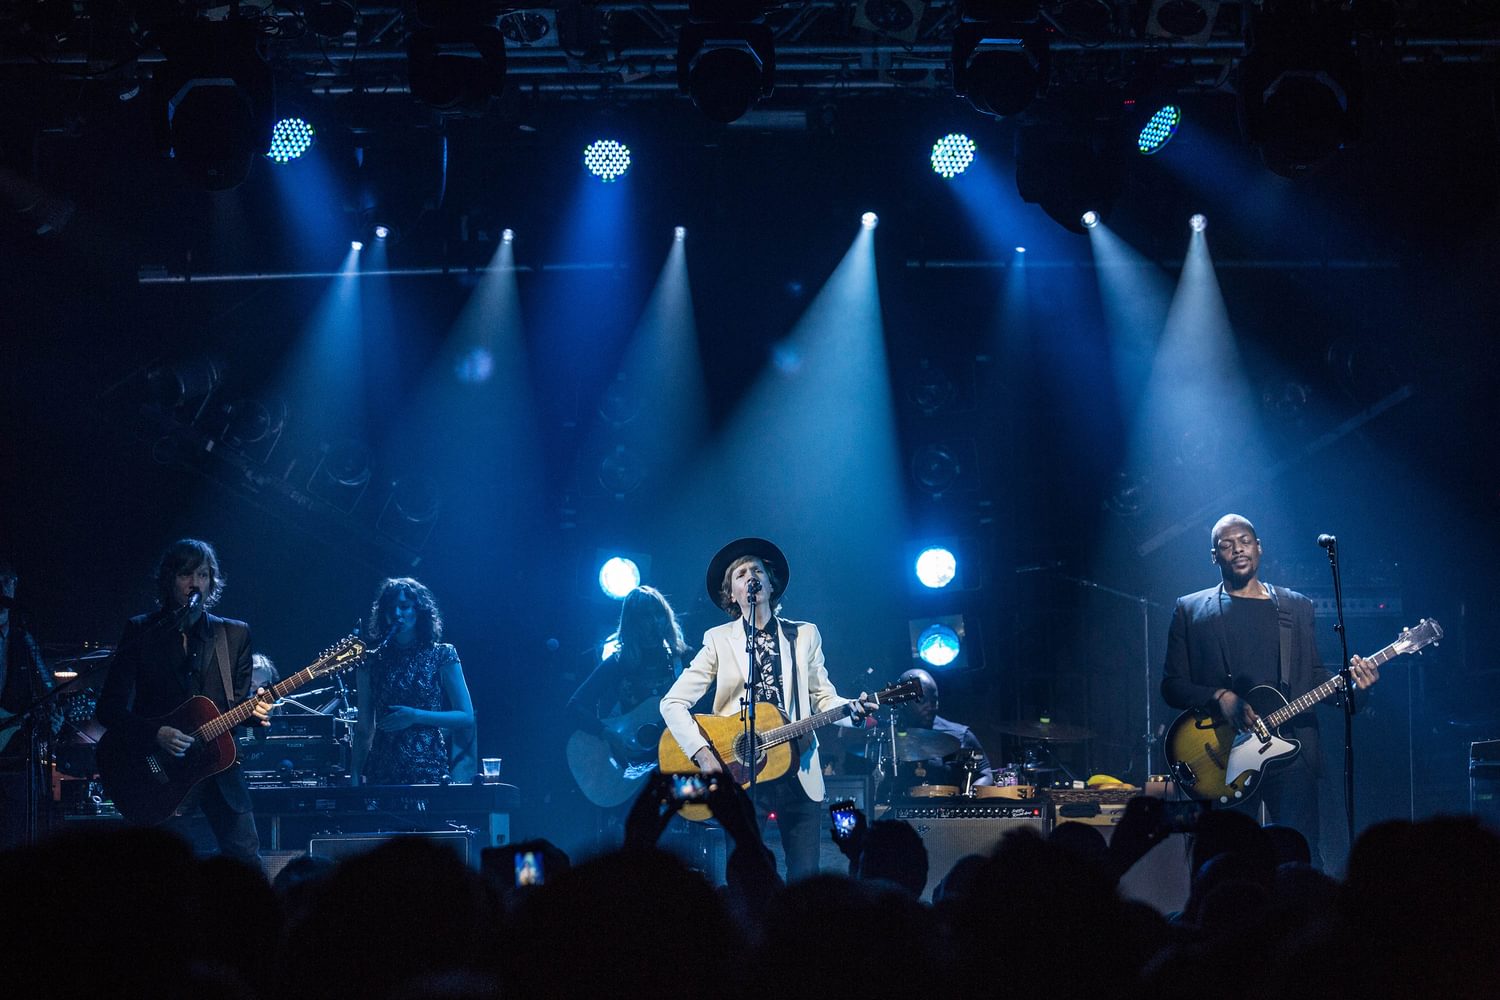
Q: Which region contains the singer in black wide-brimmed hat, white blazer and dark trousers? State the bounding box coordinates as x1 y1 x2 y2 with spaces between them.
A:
662 538 876 880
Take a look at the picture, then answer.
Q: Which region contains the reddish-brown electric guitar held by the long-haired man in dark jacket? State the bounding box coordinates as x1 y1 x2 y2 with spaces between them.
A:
98 636 365 825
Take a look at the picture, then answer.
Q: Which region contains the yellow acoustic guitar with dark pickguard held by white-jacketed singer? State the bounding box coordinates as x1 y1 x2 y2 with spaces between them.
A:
657 678 923 820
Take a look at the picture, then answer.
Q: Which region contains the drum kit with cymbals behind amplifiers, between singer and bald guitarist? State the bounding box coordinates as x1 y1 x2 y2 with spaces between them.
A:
851 720 1095 799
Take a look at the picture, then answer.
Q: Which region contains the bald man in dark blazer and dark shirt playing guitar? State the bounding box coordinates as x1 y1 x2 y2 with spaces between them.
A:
1161 514 1380 861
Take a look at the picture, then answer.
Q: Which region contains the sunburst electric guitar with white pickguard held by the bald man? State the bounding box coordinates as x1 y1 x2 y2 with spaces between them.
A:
1166 618 1443 805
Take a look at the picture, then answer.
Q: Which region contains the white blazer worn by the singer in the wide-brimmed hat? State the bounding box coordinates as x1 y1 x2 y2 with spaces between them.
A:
662 618 849 802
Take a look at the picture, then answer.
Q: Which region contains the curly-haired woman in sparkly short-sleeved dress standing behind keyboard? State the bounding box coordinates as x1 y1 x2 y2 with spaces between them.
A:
354 577 474 784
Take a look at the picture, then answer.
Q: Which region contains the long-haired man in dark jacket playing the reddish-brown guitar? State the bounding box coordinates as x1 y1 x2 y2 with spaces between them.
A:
98 538 270 865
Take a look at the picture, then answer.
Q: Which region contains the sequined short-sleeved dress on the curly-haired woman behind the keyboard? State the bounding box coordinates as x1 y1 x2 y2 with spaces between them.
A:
365 643 459 784
